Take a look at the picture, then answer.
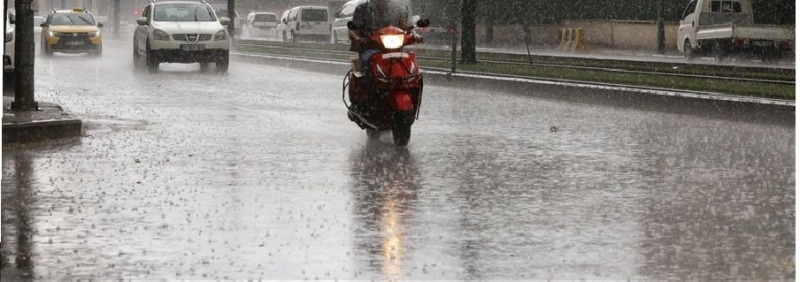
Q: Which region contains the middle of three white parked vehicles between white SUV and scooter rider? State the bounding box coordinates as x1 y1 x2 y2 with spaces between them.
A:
283 6 331 42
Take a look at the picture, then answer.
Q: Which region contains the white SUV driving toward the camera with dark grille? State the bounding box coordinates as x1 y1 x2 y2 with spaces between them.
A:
133 1 231 72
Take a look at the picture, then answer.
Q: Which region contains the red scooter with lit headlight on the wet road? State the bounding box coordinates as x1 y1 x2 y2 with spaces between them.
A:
342 16 430 146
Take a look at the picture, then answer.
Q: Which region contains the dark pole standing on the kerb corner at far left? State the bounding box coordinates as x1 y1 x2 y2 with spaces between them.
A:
11 0 39 111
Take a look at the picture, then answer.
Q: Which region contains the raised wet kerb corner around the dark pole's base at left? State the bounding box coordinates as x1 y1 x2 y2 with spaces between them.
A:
3 86 82 145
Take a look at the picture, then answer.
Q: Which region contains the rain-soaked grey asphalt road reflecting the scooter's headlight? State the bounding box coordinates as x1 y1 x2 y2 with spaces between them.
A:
2 38 795 280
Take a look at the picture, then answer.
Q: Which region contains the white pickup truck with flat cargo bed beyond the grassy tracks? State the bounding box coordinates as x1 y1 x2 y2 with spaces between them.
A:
677 0 794 60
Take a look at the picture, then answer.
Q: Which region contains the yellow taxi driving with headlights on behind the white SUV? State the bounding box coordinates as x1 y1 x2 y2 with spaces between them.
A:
41 8 103 56
